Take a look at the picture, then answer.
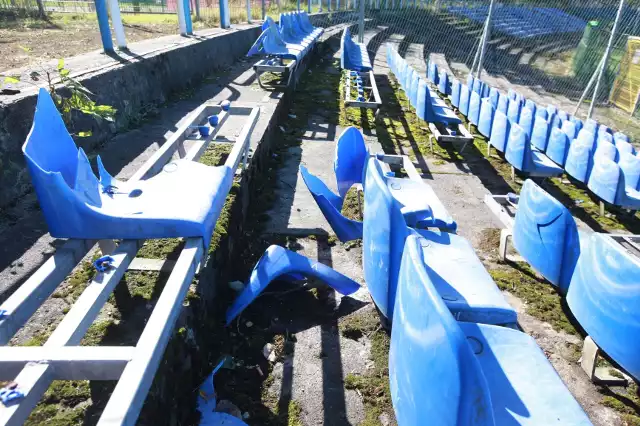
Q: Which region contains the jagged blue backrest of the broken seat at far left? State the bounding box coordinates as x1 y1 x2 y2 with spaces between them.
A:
22 89 78 188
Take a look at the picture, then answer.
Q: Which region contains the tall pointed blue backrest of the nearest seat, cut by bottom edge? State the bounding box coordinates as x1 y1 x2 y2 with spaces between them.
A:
389 235 494 426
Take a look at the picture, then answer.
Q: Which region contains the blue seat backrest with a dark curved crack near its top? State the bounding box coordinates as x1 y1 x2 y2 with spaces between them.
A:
513 179 580 293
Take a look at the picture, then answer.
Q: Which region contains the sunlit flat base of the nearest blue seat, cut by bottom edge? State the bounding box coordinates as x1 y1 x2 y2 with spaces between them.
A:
459 323 591 426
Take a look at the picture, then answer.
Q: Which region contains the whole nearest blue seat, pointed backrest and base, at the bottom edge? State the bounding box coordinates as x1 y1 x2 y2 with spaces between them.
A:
389 235 591 426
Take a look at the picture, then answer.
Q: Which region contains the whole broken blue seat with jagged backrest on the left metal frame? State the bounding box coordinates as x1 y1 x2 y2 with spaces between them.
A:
22 89 233 245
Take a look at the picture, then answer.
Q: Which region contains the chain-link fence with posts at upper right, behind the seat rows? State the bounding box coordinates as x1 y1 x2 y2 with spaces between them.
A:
364 0 640 141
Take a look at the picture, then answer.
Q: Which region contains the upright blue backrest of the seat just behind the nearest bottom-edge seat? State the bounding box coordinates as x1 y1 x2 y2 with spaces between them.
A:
362 157 408 319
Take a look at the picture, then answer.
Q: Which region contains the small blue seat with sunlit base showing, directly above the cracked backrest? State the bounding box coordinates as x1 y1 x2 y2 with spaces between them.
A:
504 124 563 177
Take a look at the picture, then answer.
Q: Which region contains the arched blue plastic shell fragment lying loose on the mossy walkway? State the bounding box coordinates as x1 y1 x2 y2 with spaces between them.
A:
226 245 360 325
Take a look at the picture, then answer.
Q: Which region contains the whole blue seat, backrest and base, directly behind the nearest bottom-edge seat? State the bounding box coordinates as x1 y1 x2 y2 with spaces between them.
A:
363 158 516 324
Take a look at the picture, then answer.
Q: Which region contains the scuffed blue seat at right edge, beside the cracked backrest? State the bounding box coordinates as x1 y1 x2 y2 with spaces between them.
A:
567 233 640 380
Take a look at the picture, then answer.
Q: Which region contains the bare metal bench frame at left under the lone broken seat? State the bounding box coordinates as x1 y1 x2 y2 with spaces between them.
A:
0 104 260 426
